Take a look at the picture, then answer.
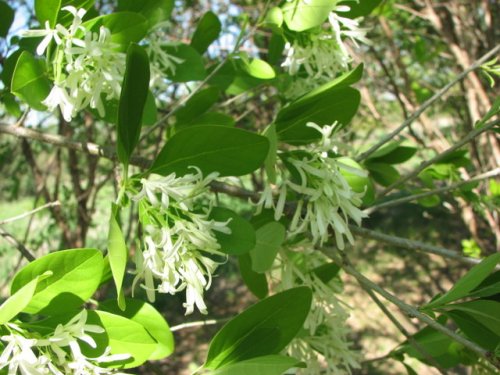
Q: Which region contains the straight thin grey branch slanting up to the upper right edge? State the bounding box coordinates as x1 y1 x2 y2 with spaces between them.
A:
356 45 500 161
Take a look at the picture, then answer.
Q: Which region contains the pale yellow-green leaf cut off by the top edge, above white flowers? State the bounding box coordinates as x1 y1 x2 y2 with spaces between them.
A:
281 0 337 31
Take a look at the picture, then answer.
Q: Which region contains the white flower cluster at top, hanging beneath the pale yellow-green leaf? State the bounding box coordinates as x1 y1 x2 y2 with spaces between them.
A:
281 5 370 97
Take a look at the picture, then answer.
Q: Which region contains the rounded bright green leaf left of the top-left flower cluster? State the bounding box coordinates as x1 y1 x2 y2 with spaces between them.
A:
11 51 50 111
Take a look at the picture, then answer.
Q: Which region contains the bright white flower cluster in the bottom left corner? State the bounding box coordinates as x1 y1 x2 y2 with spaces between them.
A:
0 310 130 375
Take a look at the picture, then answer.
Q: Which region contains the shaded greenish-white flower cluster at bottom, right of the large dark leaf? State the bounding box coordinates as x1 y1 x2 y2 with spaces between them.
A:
278 246 360 375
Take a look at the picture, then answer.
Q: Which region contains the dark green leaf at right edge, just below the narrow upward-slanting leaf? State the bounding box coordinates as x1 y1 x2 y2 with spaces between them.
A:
443 300 500 338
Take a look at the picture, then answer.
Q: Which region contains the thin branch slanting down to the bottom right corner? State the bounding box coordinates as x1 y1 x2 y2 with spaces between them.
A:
323 249 500 369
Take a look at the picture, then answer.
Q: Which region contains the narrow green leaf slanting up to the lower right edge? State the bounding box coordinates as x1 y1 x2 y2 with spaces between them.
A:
423 253 500 309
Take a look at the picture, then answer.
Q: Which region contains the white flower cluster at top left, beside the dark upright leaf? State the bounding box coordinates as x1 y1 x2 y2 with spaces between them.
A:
23 6 125 121
